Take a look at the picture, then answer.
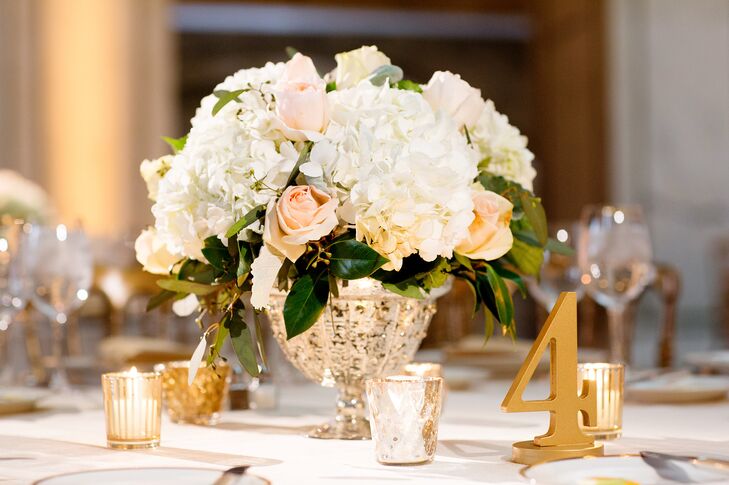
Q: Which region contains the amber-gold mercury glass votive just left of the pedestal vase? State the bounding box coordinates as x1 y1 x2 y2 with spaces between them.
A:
155 361 230 425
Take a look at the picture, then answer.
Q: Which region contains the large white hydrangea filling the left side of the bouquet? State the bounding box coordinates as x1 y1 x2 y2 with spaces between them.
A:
152 63 300 261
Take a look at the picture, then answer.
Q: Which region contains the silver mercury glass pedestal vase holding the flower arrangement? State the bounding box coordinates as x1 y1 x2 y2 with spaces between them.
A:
268 278 440 440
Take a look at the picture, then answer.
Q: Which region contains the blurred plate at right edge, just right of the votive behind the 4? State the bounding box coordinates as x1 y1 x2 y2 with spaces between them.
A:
626 375 729 404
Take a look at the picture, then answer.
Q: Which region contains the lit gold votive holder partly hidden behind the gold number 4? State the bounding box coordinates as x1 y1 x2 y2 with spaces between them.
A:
577 363 625 440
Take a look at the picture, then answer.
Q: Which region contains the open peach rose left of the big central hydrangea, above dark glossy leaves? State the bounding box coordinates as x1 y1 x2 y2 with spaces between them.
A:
263 185 339 261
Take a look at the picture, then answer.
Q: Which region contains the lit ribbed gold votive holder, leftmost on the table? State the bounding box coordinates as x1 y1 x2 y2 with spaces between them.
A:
101 368 162 449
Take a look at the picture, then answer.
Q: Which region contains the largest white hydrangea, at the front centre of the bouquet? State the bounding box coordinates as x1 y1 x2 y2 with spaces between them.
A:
310 83 477 269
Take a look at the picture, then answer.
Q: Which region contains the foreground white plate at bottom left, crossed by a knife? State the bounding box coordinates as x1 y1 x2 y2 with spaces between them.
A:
35 468 271 485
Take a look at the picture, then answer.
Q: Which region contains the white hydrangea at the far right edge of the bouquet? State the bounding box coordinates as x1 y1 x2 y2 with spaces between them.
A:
469 100 537 190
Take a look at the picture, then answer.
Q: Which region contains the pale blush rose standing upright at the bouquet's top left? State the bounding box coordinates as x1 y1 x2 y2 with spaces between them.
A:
274 53 329 136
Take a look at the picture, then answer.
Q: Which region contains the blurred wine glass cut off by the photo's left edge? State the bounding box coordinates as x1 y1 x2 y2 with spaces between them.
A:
0 218 32 384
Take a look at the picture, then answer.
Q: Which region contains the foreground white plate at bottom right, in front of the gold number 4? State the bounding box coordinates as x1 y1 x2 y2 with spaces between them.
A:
521 456 729 485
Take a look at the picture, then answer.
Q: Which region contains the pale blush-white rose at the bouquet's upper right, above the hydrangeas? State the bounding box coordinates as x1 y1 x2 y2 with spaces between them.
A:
423 71 484 129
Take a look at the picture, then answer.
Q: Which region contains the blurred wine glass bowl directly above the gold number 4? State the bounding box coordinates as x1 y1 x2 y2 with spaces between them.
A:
526 222 585 312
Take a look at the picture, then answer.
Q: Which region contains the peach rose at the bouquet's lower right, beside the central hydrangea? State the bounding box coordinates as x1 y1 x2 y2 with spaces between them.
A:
456 186 514 261
